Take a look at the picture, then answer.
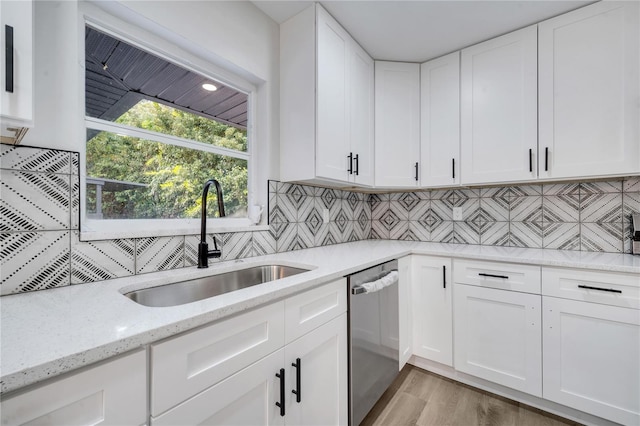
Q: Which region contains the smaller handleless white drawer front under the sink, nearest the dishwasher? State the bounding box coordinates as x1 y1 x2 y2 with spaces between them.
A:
284 278 347 343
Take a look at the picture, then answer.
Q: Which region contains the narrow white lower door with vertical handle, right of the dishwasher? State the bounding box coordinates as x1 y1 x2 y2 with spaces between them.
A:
412 256 453 366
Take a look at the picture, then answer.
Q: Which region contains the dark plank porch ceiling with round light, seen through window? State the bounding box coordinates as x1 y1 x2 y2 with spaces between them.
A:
85 27 248 129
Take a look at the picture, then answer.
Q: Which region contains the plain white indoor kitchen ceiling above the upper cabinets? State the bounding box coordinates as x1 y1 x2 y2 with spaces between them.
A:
253 0 593 62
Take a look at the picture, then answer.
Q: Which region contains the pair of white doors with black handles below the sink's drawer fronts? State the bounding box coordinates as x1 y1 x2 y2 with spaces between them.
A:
151 313 348 426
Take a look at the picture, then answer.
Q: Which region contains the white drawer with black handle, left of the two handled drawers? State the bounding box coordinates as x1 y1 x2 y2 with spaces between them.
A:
453 259 540 294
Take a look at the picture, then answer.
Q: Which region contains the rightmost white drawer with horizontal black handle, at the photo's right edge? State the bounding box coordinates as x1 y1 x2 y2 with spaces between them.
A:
542 267 640 309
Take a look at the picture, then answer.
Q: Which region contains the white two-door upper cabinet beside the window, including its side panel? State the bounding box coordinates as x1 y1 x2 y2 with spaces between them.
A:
280 5 374 186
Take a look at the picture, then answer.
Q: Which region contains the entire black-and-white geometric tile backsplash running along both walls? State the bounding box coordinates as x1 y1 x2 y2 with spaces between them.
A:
0 144 640 295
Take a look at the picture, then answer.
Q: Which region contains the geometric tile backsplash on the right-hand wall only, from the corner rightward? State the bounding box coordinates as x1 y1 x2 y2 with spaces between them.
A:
370 177 640 253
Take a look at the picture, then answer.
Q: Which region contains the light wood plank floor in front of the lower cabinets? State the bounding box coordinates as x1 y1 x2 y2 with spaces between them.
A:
361 365 579 426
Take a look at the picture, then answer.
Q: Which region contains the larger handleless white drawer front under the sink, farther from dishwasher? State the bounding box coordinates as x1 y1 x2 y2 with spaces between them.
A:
151 302 284 416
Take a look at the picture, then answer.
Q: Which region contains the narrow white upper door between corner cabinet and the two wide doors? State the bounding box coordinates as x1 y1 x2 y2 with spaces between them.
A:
420 52 460 187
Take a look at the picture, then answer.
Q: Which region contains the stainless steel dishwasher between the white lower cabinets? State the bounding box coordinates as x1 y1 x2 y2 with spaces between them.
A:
347 260 399 426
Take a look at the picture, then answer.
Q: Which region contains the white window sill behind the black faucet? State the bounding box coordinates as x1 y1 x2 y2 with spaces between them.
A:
80 219 269 241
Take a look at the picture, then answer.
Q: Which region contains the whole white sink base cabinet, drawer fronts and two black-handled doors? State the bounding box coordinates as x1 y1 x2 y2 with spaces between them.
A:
150 279 348 426
